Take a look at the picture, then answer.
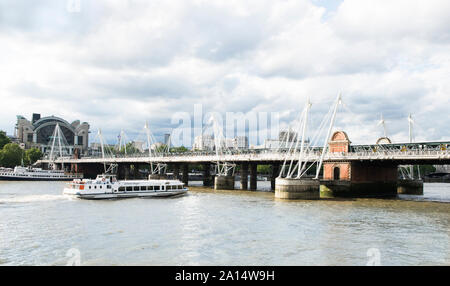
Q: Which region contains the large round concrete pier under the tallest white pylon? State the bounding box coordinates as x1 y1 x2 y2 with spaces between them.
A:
275 178 320 200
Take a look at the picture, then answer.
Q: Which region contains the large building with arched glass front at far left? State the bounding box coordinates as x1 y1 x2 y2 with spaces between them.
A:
14 113 89 154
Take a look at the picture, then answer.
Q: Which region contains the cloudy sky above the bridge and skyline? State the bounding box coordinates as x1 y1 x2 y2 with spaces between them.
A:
0 0 450 146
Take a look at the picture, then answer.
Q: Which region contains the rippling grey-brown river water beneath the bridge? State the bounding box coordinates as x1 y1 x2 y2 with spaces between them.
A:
0 182 450 265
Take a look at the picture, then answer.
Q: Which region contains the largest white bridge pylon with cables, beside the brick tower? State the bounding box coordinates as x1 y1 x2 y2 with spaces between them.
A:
278 94 342 179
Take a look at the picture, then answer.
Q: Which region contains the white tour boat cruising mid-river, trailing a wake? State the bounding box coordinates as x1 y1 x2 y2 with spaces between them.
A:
63 174 188 200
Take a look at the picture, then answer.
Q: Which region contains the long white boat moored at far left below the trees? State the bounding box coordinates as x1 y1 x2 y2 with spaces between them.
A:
0 166 83 181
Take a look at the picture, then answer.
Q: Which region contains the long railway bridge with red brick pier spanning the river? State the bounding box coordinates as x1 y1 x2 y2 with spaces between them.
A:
39 131 450 199
